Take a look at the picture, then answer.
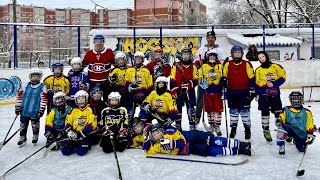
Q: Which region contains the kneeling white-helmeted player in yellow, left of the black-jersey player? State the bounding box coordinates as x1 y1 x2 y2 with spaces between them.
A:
61 90 97 156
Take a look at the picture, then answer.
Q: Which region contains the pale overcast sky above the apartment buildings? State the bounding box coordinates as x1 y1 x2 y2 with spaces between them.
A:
0 0 210 9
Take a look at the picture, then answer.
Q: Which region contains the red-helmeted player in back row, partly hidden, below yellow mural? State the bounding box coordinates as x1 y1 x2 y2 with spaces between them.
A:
146 48 171 81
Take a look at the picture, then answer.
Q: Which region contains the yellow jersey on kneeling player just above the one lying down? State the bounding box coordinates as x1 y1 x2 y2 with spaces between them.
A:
143 90 178 120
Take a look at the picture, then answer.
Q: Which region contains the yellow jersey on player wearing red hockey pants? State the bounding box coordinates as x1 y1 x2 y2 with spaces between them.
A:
198 63 222 93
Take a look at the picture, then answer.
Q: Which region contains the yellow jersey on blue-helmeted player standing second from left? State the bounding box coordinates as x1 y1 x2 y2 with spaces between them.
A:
43 75 70 95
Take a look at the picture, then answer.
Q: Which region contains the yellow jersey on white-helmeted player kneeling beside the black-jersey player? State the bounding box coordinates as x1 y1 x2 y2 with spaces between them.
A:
65 105 97 133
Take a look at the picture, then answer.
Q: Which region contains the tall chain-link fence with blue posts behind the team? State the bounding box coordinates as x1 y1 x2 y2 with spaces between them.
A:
0 23 320 68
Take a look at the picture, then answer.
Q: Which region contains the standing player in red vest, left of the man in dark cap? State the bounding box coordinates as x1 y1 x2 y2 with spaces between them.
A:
170 48 198 130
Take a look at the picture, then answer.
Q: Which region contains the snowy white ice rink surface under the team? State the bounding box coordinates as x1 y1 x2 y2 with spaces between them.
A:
0 90 320 180
